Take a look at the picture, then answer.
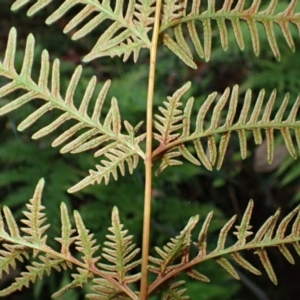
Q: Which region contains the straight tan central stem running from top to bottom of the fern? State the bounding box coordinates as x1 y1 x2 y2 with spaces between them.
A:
140 0 162 300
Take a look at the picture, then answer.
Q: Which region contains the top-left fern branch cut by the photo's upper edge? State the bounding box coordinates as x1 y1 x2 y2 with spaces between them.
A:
11 0 155 62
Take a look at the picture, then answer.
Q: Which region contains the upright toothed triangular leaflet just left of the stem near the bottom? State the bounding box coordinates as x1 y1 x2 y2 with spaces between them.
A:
97 207 141 284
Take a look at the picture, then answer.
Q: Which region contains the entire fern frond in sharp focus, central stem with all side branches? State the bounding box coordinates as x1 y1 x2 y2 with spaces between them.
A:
0 0 300 300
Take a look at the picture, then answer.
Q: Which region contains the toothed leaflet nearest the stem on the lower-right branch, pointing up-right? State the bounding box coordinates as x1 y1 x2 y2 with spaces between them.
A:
149 216 199 275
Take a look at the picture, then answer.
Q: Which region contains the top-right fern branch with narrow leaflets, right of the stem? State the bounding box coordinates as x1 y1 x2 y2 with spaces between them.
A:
160 0 300 68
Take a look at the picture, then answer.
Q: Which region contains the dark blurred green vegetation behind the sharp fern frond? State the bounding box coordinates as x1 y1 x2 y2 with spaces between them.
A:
0 0 300 300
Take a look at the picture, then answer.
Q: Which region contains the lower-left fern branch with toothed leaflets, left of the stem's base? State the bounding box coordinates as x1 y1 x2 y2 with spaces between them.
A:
0 179 140 300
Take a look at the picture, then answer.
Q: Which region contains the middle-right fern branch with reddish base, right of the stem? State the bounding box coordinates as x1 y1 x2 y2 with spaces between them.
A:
154 83 300 173
